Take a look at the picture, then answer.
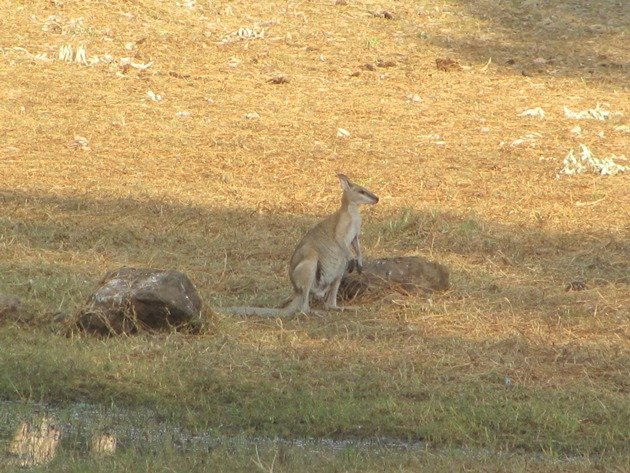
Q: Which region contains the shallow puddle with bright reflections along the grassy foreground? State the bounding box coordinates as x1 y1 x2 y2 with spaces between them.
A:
0 401 588 466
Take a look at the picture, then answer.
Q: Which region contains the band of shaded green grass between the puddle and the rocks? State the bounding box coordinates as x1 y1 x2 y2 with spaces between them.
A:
0 324 630 455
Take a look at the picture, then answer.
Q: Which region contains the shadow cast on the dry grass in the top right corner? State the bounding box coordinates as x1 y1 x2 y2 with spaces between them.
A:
428 0 630 86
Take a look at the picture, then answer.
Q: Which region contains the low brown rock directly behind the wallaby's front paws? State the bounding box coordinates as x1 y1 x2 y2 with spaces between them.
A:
339 256 449 300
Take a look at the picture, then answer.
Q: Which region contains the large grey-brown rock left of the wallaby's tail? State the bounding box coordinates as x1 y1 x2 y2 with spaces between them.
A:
77 268 202 335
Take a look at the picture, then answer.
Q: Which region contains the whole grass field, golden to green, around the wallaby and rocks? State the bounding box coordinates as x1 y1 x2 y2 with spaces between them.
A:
0 0 630 471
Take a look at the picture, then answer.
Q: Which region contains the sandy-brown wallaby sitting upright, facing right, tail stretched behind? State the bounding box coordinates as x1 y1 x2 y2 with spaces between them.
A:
219 174 378 316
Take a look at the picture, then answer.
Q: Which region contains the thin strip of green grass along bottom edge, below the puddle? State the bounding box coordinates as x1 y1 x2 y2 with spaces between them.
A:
11 445 628 473
